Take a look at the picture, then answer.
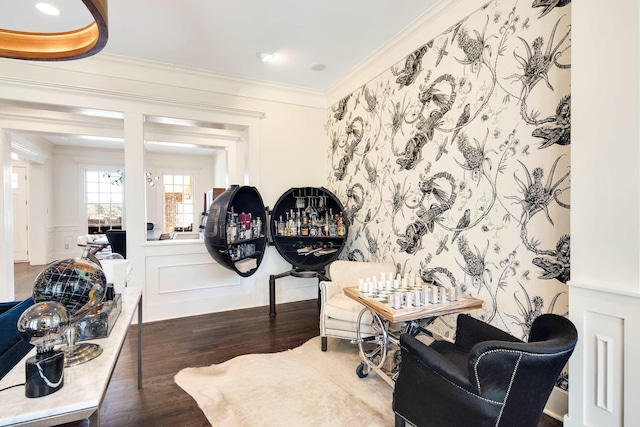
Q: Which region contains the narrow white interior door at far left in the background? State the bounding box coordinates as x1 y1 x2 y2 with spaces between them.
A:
11 166 29 262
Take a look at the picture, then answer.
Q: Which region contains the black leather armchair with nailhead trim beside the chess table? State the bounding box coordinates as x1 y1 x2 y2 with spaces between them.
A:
393 314 578 427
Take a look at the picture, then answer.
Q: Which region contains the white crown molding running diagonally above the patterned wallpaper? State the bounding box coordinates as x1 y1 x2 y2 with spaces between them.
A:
326 0 488 107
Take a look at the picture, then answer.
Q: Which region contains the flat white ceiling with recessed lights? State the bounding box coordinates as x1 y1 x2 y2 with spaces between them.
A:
0 0 439 91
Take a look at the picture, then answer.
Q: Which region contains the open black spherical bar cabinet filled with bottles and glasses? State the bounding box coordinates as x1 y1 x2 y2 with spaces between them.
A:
204 185 349 315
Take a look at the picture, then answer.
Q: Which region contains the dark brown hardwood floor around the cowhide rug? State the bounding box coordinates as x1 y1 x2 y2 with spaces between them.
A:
53 300 562 427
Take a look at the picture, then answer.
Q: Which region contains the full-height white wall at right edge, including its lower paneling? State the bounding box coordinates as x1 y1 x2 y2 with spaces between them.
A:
565 0 640 426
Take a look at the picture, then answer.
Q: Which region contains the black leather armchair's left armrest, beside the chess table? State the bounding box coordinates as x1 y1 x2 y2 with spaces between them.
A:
400 334 477 393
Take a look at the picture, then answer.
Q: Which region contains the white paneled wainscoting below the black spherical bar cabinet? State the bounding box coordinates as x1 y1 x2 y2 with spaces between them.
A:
142 240 318 322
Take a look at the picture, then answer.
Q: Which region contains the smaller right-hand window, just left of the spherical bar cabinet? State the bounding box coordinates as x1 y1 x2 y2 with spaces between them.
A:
162 175 193 233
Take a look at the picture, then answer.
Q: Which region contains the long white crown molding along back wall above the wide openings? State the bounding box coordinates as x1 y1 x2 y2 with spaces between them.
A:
0 53 326 110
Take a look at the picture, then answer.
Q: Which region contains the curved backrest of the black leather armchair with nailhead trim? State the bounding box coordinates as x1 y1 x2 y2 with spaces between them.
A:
468 314 578 426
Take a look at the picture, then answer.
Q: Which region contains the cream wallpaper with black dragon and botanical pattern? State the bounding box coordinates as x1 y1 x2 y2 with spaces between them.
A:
326 0 571 372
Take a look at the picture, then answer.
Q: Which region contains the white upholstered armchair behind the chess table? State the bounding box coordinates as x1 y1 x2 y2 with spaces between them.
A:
320 260 396 351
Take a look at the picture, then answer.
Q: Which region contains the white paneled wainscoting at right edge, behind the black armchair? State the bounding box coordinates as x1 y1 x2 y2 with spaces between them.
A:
564 283 640 427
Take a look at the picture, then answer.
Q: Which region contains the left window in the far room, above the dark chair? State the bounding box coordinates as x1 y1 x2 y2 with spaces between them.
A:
85 170 123 233
